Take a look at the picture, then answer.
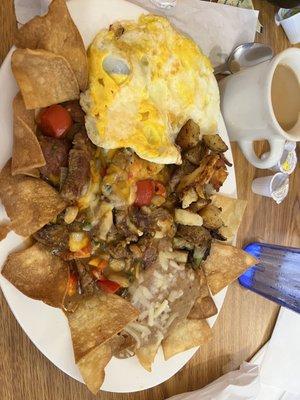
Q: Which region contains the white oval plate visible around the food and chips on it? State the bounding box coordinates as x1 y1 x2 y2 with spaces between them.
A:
0 0 236 393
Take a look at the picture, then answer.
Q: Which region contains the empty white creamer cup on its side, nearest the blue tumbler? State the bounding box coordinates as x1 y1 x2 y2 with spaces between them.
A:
252 172 289 204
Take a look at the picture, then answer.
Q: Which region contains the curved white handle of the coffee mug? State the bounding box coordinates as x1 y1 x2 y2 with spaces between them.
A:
238 138 285 169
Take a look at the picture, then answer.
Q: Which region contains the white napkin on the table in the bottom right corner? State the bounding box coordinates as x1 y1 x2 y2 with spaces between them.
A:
169 308 300 400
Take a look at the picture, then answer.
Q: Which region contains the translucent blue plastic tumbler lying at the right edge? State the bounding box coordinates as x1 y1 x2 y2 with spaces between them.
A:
239 242 300 313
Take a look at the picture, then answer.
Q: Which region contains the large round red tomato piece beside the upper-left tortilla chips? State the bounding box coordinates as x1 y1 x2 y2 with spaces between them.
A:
38 104 73 138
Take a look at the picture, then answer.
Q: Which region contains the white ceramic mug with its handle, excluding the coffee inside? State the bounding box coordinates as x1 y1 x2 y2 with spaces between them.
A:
219 48 300 168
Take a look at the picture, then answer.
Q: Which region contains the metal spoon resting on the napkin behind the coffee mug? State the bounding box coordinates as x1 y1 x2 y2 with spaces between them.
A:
214 42 273 75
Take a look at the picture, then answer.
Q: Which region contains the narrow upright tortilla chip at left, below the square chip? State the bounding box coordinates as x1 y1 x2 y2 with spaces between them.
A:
11 93 46 175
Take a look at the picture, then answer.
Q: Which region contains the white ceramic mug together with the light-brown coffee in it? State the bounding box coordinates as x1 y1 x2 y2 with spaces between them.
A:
219 48 300 168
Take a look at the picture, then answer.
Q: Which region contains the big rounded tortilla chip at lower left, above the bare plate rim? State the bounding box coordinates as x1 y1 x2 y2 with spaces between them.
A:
2 243 69 307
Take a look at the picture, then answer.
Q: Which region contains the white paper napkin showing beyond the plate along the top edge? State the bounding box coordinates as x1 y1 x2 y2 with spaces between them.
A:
15 0 258 66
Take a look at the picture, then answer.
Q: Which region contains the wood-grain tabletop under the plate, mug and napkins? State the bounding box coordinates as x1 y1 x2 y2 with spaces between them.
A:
0 0 300 400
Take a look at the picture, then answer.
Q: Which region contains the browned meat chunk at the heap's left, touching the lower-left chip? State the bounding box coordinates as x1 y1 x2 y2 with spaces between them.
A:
33 224 69 254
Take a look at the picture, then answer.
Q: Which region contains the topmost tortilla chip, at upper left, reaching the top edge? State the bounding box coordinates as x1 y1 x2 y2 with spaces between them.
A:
16 0 88 91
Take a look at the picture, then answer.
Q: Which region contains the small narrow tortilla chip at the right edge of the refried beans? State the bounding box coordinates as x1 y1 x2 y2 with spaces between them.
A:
188 269 218 319
